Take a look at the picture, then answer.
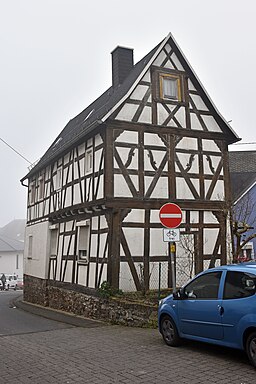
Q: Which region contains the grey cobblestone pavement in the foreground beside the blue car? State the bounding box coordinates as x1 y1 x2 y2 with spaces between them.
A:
0 325 256 384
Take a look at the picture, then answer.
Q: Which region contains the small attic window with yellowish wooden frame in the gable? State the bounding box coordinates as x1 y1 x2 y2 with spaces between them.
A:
160 74 181 101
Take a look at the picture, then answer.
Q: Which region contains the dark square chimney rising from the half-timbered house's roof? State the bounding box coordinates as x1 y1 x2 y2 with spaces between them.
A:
111 47 133 88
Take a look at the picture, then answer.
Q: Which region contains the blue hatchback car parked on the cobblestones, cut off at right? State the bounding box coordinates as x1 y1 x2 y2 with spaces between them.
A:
158 262 256 367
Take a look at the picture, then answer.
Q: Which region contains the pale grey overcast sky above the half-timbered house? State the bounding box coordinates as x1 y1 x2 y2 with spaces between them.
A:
0 0 256 227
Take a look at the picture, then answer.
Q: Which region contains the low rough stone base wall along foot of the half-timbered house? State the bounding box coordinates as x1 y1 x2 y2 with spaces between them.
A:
24 275 157 327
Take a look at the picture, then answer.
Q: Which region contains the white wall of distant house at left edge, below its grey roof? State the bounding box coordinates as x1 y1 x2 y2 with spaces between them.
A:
0 251 23 277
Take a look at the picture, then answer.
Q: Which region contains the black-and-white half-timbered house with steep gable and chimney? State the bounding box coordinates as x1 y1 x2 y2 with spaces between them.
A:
21 34 238 290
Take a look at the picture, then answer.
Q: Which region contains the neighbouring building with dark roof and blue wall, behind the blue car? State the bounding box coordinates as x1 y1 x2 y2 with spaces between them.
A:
229 151 256 260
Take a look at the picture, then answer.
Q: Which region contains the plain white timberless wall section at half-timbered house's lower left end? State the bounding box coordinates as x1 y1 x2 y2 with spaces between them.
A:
24 221 50 279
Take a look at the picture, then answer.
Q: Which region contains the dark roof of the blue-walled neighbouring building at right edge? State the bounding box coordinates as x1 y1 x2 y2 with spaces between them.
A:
229 151 256 201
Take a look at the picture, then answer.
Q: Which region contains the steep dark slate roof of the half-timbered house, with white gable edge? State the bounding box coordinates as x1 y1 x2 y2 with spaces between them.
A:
21 34 239 182
